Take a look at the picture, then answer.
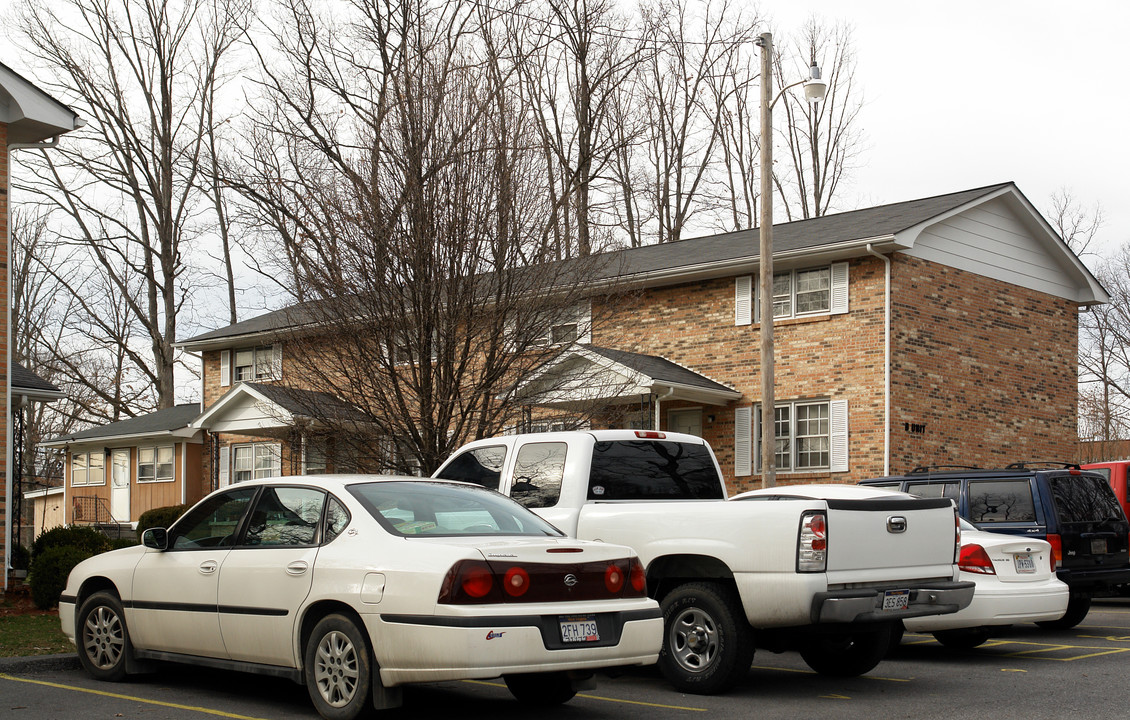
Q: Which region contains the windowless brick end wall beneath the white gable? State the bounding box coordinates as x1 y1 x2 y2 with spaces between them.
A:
890 255 1078 472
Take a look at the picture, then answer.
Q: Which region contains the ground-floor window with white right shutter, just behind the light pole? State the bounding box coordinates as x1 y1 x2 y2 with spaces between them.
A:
753 400 848 472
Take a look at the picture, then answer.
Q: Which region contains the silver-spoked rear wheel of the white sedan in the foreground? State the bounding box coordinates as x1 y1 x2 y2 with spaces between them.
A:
305 615 372 720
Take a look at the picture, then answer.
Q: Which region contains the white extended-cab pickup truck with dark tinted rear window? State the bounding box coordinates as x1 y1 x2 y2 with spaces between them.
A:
435 430 973 694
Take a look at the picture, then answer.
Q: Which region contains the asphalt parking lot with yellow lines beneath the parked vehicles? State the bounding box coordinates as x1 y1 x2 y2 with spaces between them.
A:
8 599 1130 720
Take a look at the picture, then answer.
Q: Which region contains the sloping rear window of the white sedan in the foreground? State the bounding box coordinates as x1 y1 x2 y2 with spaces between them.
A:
349 480 562 537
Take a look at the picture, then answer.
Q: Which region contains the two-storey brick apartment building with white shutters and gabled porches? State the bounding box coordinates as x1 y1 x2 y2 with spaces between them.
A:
48 183 1107 522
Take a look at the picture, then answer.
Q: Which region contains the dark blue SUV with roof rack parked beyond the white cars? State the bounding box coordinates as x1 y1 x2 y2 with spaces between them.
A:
860 462 1130 628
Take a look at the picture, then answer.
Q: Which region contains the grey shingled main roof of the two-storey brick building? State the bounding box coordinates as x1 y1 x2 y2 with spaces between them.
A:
177 182 1109 350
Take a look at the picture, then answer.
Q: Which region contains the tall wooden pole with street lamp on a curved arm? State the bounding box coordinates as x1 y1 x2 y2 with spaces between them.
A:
754 33 828 487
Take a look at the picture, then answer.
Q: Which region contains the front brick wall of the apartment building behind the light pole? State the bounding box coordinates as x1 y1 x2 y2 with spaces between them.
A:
593 258 884 492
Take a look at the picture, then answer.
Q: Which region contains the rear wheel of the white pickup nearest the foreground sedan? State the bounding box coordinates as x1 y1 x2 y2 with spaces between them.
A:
659 582 754 695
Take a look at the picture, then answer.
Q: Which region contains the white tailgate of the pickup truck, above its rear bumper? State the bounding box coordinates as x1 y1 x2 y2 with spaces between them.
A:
827 497 956 584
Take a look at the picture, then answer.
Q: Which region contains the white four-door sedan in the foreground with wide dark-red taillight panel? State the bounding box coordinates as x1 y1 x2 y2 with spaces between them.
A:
59 476 662 720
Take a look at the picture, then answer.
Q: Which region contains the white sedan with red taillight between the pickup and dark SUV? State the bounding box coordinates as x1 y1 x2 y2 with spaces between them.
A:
903 520 1070 648
